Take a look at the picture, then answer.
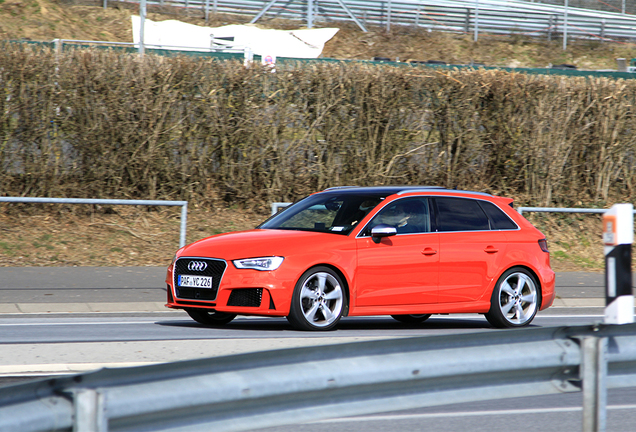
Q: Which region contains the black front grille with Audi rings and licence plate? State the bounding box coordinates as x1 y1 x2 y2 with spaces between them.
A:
174 258 227 300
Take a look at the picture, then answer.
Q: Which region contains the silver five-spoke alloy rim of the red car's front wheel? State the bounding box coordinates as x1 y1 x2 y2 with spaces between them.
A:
300 272 344 327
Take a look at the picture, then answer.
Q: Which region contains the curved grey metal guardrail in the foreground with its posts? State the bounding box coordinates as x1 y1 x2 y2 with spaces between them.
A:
0 324 636 432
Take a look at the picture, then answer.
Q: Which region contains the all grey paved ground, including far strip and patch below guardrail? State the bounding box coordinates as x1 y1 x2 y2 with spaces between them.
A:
0 267 636 432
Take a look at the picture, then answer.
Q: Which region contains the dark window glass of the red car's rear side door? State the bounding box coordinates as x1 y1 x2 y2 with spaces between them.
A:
435 198 490 231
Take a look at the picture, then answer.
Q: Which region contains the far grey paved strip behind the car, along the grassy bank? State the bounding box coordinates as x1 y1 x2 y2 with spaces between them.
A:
0 267 605 314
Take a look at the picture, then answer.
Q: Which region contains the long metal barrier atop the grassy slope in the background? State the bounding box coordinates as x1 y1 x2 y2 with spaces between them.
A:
114 0 636 47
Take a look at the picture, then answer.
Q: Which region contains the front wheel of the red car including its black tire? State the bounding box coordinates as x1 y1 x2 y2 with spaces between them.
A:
287 267 347 331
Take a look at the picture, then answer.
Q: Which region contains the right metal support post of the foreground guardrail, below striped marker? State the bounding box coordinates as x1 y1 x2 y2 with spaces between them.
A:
580 336 607 432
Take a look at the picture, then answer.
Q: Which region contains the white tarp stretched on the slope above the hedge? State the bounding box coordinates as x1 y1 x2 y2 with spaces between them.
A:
132 16 338 58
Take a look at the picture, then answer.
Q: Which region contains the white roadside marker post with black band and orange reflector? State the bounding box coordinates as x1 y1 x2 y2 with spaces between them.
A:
603 204 634 324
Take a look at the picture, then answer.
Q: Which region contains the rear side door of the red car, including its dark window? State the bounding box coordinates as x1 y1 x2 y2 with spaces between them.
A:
434 197 507 303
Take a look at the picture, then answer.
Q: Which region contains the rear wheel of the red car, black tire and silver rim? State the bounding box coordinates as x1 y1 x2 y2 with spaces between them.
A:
486 267 541 328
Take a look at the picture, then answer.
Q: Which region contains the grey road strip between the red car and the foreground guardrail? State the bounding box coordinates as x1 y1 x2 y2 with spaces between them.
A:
0 309 602 377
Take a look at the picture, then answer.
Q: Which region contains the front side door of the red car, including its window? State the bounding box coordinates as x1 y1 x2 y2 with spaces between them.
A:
355 197 439 306
